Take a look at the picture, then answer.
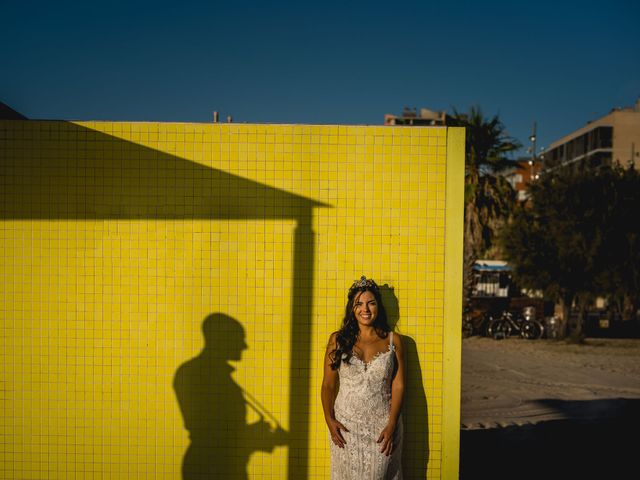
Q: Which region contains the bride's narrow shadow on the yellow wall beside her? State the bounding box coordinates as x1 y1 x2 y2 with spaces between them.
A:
380 284 429 478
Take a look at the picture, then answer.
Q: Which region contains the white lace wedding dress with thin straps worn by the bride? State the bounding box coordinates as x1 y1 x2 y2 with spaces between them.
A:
329 332 402 480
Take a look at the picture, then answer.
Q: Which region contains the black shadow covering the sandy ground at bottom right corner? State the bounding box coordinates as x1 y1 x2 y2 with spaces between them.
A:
460 399 640 480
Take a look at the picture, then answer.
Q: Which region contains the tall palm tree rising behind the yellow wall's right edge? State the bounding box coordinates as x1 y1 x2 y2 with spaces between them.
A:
448 106 521 301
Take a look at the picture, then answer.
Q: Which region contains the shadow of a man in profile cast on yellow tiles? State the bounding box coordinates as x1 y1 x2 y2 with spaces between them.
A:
174 313 287 480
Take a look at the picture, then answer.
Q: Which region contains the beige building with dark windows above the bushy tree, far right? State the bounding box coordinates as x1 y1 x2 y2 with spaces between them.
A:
544 99 640 169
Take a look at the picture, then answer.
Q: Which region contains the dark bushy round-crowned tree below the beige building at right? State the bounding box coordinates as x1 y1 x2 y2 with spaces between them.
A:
501 166 640 338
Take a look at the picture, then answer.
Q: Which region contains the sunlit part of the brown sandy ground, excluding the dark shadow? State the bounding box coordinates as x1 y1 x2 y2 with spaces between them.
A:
461 337 640 429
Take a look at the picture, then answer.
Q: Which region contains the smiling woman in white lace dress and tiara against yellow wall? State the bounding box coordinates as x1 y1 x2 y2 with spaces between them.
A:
321 276 405 480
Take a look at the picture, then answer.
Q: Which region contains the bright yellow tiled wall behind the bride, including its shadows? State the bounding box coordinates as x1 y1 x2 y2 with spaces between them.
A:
0 121 463 479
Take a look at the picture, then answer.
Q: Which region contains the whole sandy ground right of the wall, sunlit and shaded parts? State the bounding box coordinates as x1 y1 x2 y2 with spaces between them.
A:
460 337 640 479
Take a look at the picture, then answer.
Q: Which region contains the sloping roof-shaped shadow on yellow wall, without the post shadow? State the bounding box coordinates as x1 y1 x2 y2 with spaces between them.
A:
0 120 328 223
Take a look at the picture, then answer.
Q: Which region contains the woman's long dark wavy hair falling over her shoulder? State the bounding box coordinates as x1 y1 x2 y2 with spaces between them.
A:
329 277 391 370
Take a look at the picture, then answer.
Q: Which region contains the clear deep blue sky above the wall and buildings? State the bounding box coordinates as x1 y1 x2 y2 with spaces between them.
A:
0 0 640 153
